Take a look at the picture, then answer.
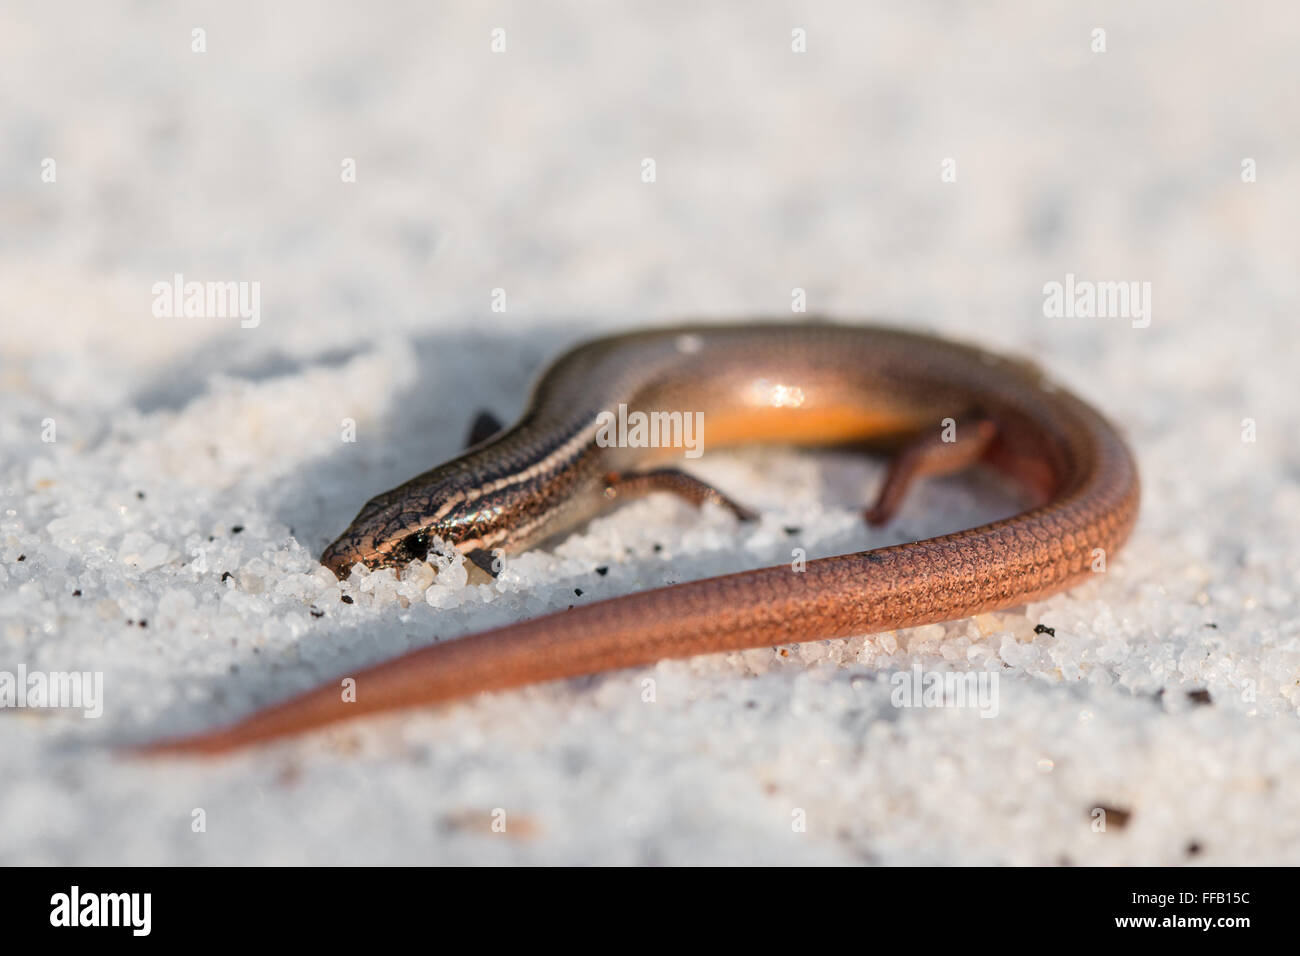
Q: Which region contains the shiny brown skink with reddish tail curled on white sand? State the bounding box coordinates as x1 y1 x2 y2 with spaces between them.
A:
144 323 1139 753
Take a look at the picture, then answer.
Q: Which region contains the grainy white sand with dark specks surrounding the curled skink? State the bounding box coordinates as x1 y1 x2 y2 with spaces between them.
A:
0 3 1300 864
